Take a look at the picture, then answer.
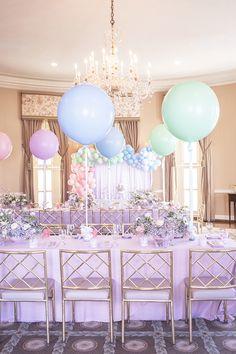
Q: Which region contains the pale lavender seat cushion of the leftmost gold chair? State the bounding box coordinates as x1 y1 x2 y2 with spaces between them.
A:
1 278 55 301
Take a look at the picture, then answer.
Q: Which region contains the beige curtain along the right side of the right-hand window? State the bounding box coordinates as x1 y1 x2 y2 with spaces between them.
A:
199 137 214 221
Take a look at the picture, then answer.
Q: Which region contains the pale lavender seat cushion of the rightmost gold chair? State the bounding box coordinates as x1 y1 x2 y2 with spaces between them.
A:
184 277 236 300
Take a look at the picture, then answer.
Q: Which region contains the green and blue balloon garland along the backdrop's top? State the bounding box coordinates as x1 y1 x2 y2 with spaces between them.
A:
72 145 161 172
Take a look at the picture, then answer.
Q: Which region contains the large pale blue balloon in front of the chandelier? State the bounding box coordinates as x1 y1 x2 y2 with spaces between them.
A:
57 84 115 145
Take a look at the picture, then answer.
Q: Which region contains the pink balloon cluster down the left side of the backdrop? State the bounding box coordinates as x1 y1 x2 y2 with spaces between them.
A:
68 162 96 197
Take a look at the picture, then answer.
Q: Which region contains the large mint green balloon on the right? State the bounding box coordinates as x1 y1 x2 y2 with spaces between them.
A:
162 81 220 142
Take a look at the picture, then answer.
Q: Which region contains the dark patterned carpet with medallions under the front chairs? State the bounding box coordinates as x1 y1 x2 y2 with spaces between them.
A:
0 318 236 354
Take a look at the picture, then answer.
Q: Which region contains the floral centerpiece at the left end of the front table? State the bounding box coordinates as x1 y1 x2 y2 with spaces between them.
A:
0 209 42 238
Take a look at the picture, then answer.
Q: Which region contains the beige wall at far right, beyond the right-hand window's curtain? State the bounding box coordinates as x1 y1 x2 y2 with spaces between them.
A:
211 84 236 219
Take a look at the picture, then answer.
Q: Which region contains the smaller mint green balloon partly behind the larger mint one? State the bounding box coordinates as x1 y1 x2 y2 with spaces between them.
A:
150 124 177 156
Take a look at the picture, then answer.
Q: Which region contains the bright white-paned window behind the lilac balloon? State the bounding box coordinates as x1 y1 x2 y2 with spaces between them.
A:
33 121 61 208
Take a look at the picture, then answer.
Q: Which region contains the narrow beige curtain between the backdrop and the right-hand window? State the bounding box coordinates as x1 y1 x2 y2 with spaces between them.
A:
165 153 176 202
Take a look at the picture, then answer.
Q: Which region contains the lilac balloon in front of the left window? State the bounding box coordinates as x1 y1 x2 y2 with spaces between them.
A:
30 129 59 160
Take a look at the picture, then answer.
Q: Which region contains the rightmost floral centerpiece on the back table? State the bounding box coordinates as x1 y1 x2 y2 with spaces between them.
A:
129 192 160 208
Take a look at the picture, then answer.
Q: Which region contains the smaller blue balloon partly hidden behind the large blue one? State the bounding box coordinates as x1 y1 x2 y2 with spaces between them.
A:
96 127 125 159
